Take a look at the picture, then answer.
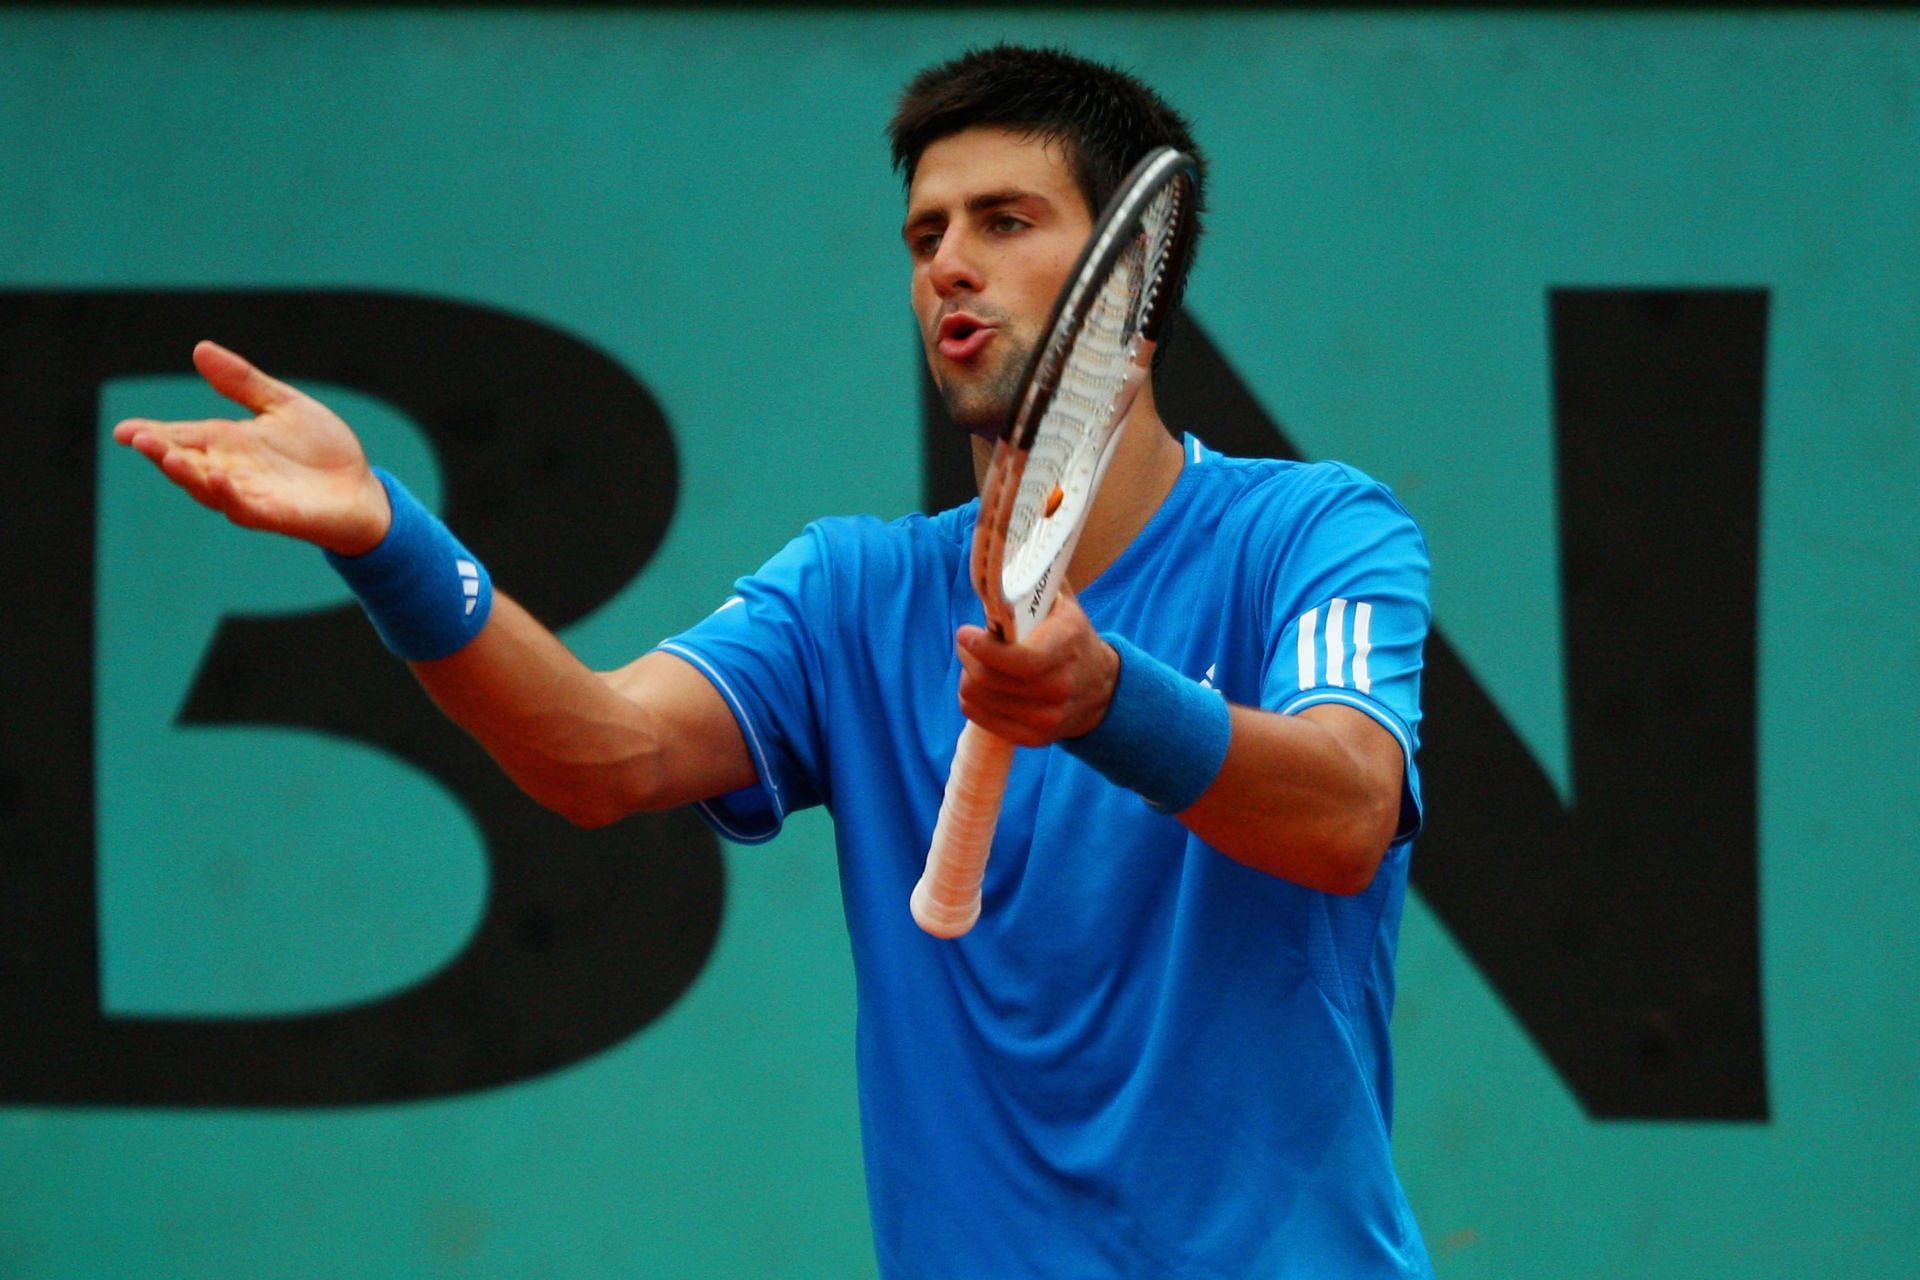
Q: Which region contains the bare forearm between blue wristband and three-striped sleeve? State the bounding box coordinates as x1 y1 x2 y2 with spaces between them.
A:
1179 706 1400 894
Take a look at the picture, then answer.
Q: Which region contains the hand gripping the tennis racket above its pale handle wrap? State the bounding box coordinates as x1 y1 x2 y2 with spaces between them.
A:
954 587 1119 747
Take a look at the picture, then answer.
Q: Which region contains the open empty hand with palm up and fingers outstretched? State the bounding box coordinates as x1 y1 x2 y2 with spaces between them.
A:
113 342 392 555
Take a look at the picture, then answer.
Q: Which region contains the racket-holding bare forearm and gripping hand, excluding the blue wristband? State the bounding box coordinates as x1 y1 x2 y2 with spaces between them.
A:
958 593 1405 894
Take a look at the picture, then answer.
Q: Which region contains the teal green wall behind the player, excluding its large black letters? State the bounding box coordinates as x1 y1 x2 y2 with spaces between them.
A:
0 12 1920 1280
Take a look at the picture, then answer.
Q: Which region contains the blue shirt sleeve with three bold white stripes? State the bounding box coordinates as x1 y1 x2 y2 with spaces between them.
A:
1261 468 1430 841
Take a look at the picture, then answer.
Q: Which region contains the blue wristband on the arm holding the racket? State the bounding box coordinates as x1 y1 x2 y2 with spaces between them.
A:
1060 631 1233 814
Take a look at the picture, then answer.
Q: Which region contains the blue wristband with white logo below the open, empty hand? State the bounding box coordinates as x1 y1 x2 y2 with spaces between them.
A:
326 466 493 662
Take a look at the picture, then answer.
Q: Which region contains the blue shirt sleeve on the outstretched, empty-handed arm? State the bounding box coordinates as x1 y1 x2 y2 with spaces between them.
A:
659 526 833 844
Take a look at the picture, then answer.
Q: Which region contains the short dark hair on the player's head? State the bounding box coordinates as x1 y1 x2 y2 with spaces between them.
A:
887 44 1206 326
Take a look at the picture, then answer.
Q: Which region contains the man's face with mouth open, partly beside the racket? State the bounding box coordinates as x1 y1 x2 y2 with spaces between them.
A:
900 127 1092 436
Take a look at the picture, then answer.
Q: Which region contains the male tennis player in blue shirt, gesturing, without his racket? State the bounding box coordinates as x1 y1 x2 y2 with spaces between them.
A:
115 46 1430 1280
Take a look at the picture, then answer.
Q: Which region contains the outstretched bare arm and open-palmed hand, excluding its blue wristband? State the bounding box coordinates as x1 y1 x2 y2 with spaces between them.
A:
113 342 755 825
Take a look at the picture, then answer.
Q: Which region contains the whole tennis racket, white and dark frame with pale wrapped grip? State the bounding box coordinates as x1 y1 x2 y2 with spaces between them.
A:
912 148 1194 938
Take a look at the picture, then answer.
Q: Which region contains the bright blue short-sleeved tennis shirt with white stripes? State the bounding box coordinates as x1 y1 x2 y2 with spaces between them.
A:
662 436 1432 1280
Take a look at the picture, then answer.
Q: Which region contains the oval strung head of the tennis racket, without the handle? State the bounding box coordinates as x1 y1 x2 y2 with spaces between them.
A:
972 148 1194 641
